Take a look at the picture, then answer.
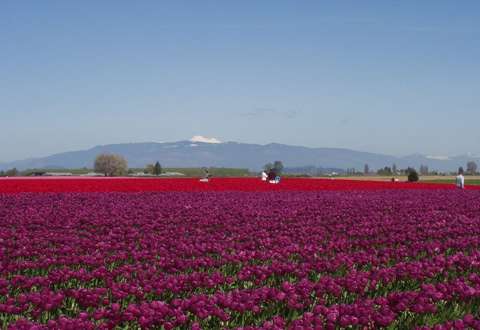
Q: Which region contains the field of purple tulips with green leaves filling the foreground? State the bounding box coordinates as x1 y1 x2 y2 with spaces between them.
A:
0 189 480 329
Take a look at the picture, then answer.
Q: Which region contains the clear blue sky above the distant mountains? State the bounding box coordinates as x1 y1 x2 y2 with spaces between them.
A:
0 0 480 161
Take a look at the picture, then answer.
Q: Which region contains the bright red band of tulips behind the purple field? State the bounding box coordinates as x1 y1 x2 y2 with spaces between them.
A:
0 177 480 193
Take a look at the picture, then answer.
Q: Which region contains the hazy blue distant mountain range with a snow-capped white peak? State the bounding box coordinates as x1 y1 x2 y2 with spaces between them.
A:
0 139 480 171
